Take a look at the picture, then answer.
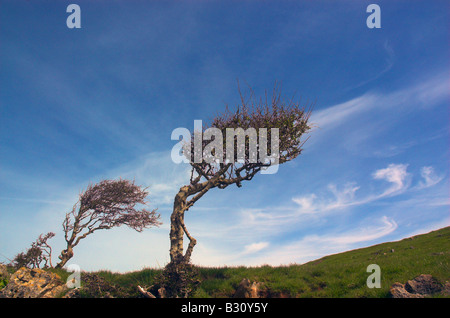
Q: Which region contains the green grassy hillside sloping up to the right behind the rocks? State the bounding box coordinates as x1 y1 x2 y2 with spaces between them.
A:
80 227 450 298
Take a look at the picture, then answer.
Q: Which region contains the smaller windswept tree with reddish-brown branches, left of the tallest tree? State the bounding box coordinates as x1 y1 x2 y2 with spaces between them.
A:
56 179 161 268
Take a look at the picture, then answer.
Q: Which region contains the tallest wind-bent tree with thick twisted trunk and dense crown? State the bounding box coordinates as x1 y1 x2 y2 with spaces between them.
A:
163 85 312 296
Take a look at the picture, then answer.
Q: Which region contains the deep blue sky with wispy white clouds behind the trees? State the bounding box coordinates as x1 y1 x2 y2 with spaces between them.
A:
0 0 450 271
